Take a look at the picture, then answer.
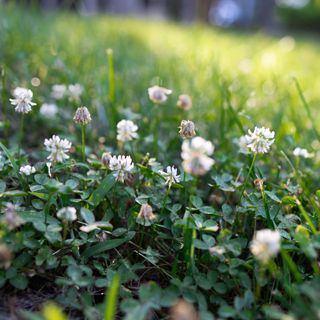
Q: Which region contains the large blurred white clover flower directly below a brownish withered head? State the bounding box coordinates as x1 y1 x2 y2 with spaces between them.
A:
181 137 214 176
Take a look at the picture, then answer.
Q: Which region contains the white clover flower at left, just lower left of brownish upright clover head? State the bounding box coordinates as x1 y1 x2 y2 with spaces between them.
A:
44 135 71 162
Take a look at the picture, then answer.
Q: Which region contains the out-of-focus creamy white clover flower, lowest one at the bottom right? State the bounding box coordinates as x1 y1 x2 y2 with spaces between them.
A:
250 229 281 263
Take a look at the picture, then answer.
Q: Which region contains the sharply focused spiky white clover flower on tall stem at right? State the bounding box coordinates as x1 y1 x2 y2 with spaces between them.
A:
246 127 275 153
